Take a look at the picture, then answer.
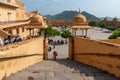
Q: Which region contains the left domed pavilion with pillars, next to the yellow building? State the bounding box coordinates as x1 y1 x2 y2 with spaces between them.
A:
26 11 48 35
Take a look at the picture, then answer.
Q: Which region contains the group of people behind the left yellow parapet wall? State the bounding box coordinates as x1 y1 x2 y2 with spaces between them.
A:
0 35 22 46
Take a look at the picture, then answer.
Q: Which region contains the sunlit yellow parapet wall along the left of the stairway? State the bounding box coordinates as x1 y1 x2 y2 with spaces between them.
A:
0 37 43 80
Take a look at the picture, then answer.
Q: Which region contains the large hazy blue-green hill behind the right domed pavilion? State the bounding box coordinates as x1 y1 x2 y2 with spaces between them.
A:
46 11 100 20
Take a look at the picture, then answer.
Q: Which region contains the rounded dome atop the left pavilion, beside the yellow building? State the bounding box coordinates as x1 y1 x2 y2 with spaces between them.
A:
30 13 44 26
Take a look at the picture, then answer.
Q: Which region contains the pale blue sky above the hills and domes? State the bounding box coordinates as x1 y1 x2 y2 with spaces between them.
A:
20 0 120 17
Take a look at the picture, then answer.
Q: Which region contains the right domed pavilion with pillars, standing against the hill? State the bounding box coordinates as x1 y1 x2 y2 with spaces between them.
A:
72 11 90 37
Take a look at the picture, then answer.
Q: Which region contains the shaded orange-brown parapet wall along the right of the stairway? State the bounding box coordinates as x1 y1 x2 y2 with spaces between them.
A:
73 37 120 77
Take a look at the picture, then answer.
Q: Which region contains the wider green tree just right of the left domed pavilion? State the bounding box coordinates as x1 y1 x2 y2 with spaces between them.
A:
44 26 60 37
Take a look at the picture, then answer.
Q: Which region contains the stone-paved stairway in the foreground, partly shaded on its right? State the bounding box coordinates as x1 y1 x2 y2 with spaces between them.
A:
5 59 120 80
